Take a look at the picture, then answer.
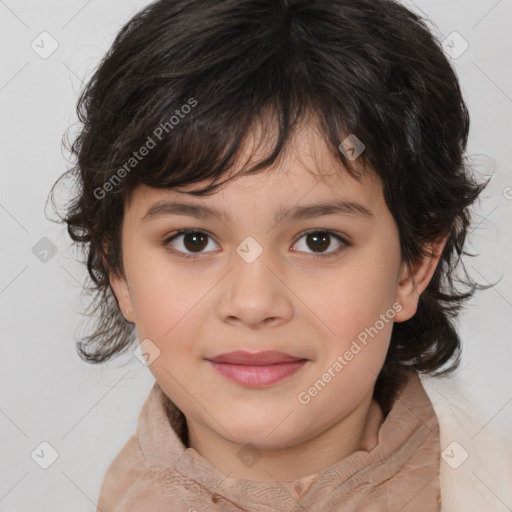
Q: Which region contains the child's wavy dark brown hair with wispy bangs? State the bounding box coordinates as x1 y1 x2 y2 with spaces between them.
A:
52 0 492 386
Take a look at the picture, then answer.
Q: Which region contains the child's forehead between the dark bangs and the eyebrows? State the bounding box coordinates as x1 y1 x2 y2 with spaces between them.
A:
125 124 385 219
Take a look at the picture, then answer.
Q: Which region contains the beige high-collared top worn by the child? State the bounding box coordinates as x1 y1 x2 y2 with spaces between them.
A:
97 372 440 512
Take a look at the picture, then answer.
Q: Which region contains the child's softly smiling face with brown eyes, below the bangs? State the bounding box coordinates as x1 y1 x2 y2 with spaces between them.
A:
111 123 444 449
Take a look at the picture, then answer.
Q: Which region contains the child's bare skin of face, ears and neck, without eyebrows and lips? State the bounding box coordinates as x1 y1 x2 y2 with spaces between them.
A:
110 125 446 481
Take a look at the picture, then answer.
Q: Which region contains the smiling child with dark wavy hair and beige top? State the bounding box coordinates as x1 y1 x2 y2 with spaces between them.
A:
51 0 512 512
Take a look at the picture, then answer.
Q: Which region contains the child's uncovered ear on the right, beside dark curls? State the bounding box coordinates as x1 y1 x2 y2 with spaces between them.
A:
395 236 448 322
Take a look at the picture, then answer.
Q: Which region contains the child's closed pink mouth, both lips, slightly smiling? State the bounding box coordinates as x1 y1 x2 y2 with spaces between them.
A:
207 350 309 388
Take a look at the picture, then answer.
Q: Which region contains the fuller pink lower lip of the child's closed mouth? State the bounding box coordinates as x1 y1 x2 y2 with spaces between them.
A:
208 359 307 388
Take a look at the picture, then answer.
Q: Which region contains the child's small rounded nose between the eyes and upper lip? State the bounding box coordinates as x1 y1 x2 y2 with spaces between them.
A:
217 242 294 330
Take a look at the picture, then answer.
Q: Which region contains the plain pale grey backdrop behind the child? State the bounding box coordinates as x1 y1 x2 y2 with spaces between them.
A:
0 0 512 512
